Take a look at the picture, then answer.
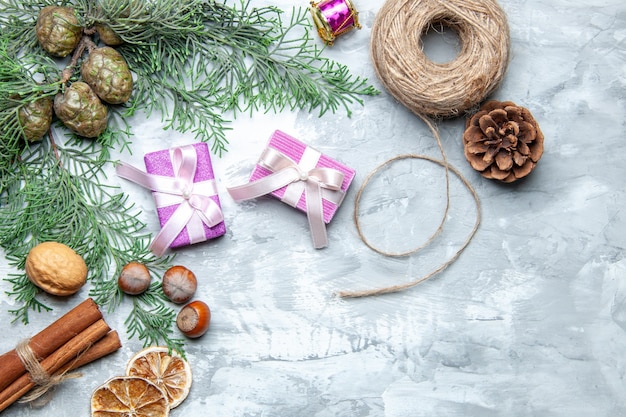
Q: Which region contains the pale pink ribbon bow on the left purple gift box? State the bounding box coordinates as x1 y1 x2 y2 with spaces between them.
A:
116 145 224 256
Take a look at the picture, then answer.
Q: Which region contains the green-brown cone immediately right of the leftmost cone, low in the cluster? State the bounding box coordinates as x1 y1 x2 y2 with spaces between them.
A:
54 81 108 138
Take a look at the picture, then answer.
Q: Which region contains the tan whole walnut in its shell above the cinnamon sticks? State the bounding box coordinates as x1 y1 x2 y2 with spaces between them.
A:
24 242 87 296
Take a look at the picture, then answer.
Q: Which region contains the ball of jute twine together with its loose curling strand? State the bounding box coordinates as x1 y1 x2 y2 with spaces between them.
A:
337 0 510 298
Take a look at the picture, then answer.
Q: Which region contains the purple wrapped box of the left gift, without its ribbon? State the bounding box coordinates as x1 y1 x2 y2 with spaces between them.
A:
144 142 226 248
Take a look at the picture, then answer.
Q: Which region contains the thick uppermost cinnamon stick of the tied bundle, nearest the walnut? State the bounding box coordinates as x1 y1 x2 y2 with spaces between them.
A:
0 298 102 392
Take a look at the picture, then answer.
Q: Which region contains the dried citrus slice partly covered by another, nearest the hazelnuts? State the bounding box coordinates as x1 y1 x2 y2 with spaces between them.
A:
126 346 192 408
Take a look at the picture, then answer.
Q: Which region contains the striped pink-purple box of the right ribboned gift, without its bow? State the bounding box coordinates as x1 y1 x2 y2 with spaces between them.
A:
250 130 356 224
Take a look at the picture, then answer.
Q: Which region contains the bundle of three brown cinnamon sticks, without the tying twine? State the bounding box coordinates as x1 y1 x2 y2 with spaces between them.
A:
0 298 122 412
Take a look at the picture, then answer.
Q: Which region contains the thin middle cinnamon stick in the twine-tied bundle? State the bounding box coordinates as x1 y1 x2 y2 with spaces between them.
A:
0 319 111 412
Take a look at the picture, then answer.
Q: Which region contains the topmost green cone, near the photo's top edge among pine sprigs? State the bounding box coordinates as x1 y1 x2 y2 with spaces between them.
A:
35 6 83 57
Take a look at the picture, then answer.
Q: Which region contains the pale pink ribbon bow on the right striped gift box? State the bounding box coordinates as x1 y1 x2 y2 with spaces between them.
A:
228 147 344 249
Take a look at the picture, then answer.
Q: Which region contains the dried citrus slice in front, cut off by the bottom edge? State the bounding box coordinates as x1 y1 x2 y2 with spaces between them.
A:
91 376 170 417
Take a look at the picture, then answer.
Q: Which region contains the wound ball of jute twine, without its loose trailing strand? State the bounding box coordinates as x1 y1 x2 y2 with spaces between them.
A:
370 0 510 117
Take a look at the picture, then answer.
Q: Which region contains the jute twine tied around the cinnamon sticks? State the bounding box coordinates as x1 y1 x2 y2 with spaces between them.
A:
15 339 81 405
